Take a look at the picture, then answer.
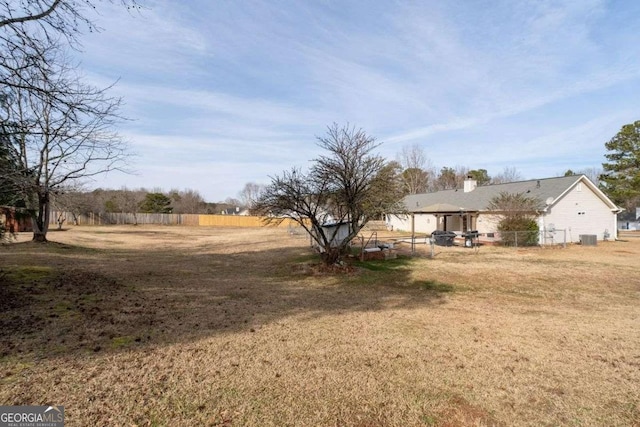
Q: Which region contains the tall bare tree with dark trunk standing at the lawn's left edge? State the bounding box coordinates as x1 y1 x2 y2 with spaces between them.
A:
8 47 126 241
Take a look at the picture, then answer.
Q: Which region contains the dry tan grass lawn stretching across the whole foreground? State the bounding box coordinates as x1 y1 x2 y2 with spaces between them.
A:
0 226 640 427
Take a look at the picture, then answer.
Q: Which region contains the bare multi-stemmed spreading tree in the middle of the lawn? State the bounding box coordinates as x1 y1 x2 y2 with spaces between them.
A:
257 124 402 264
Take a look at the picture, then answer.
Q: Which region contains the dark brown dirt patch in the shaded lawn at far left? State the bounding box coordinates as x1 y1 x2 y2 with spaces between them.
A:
0 267 154 357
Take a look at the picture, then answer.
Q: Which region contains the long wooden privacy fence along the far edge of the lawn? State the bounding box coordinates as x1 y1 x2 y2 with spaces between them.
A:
49 211 297 228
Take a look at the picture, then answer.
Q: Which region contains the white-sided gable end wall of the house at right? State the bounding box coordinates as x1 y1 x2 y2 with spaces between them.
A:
542 183 617 242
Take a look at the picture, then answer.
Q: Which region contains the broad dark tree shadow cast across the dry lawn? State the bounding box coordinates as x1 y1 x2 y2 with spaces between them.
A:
0 244 454 360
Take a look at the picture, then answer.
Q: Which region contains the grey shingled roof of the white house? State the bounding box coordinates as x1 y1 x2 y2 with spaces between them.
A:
404 175 619 213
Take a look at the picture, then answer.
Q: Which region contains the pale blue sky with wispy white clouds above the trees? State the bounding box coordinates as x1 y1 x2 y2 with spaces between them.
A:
78 0 640 202
